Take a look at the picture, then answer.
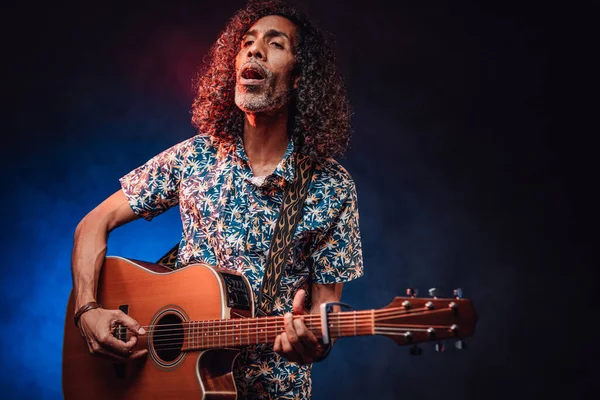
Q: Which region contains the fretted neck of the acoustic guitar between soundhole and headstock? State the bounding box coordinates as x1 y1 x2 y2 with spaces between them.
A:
182 310 375 351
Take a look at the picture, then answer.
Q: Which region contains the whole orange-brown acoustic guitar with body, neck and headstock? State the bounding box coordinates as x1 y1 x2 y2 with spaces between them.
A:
62 256 477 400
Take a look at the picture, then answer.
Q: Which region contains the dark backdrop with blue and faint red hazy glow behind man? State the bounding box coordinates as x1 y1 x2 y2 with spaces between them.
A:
0 0 600 400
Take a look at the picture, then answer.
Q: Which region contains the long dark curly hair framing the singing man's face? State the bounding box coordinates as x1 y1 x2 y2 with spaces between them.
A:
191 0 351 158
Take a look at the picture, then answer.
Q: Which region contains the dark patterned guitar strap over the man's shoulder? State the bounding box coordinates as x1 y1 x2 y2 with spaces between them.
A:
157 153 315 316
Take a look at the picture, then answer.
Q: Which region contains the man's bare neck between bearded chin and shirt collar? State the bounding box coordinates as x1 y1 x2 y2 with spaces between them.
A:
243 107 290 176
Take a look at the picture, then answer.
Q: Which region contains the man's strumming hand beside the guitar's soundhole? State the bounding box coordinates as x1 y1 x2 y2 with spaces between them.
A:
79 308 148 362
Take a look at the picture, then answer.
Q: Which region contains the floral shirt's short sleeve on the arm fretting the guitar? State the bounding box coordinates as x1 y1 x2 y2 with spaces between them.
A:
312 182 363 284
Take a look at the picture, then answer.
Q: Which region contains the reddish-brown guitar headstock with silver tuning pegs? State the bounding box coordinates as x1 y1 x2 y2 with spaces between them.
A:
374 289 478 354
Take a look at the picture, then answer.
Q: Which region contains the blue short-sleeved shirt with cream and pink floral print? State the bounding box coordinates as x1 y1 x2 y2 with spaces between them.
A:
120 135 363 399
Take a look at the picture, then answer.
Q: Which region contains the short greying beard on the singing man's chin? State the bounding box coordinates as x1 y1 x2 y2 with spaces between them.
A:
235 74 292 112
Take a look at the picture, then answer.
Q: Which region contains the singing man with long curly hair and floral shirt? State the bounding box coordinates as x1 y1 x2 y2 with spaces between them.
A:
72 1 363 398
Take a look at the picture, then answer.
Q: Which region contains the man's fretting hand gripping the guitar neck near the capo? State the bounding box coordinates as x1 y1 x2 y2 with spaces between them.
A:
273 289 325 364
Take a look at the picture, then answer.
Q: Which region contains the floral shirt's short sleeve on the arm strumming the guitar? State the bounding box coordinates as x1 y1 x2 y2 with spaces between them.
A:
119 138 195 221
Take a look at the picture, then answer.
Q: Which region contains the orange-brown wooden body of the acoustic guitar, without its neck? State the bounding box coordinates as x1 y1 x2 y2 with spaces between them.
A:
62 257 254 400
